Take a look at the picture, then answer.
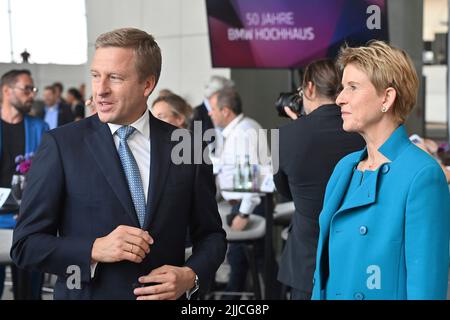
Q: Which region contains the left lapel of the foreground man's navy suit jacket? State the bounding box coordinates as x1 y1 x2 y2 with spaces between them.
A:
85 119 139 227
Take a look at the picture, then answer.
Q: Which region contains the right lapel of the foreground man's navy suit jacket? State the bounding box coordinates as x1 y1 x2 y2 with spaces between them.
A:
144 113 172 229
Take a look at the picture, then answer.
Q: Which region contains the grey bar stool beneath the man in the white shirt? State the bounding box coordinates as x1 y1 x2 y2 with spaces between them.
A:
221 214 266 300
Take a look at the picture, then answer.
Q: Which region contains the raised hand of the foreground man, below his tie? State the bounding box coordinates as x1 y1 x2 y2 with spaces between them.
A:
91 225 153 263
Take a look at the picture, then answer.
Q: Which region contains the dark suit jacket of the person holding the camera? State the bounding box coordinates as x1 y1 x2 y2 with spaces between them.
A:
274 104 365 293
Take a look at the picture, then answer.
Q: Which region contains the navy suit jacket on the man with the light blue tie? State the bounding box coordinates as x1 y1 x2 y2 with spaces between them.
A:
11 114 226 299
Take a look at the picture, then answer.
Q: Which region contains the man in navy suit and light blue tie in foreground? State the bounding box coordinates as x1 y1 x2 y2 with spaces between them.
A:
11 28 226 300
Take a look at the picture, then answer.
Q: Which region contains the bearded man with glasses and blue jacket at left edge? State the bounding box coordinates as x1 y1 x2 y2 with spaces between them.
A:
0 70 48 299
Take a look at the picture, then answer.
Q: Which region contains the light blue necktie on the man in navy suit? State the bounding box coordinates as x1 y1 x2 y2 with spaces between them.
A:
117 126 146 227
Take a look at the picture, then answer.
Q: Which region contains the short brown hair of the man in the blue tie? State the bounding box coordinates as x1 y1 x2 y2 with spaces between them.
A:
95 28 162 85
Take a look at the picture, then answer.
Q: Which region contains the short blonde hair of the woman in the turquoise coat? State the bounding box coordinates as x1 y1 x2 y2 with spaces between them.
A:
337 41 419 124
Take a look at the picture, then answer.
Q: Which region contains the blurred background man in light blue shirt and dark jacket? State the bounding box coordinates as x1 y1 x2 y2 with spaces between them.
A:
35 86 75 129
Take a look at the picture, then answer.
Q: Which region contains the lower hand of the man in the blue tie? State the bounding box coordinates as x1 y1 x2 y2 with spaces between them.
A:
134 265 195 300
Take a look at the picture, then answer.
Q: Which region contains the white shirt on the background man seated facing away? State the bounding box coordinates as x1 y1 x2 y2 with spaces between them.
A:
211 114 268 214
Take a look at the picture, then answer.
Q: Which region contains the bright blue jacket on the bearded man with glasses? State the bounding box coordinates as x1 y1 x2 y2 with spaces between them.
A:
0 116 49 229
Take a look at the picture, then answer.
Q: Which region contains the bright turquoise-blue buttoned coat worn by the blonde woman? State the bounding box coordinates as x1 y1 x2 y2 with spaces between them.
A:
312 126 450 300
